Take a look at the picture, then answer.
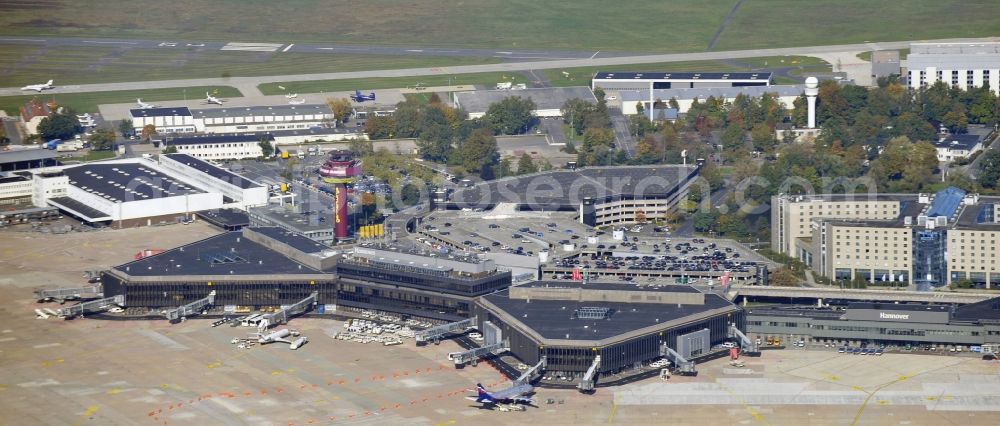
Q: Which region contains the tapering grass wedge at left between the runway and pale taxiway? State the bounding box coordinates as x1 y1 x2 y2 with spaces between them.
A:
0 45 499 87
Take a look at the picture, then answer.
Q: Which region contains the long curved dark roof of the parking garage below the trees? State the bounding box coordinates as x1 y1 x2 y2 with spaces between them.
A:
451 165 695 208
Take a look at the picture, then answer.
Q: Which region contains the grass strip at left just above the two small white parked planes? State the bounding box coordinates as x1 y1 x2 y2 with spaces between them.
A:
0 86 243 115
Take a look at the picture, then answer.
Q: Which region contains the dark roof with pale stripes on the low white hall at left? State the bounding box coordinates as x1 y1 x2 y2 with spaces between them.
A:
63 163 202 202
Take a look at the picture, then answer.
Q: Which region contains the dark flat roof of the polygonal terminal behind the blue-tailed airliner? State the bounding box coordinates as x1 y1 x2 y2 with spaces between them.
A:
483 283 735 340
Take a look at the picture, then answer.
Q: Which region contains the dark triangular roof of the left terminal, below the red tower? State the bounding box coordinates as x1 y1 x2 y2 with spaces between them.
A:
115 231 323 276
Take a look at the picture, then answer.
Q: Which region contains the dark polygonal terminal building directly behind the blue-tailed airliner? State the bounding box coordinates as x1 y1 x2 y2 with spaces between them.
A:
475 281 745 374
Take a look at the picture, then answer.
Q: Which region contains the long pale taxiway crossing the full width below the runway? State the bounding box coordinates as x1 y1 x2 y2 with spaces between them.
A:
0 39 992 96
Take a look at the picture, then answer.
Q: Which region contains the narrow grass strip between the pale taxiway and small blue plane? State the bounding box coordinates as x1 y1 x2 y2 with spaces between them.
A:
257 72 530 95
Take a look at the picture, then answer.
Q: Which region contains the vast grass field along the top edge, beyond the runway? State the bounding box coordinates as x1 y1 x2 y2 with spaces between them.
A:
0 0 1000 52
